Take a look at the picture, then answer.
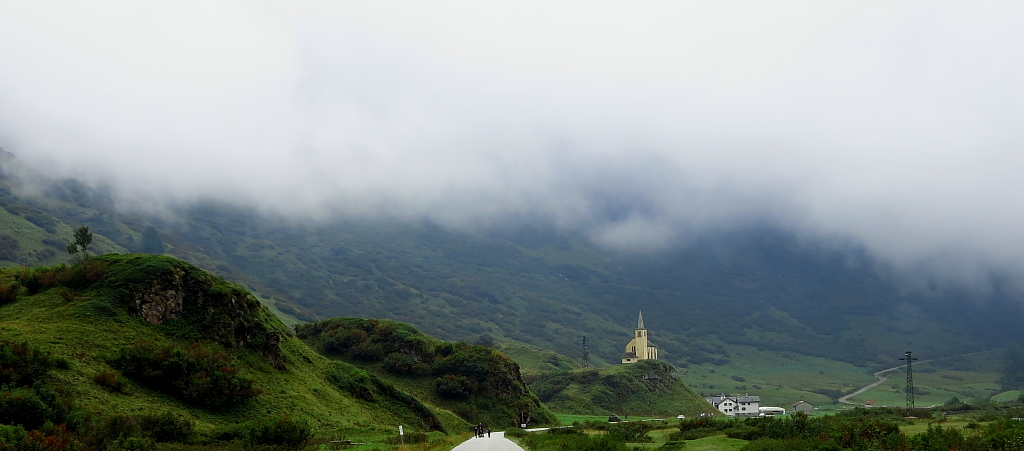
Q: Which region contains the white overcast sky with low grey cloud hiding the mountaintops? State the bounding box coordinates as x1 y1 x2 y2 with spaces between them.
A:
0 1 1024 280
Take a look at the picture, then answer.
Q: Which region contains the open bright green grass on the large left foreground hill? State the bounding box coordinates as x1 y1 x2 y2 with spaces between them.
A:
0 257 448 439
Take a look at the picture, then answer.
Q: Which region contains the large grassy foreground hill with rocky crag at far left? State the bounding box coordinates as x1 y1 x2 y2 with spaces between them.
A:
0 254 466 446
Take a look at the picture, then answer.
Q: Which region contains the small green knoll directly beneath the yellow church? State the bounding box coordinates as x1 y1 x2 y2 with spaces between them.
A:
526 360 717 418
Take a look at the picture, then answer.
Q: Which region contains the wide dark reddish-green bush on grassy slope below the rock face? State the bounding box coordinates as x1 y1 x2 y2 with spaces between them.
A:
110 342 259 407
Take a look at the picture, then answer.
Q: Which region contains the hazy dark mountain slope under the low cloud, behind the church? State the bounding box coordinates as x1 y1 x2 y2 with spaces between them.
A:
2 156 1020 366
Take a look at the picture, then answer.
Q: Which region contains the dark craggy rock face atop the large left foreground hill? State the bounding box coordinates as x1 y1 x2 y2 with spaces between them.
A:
125 260 284 369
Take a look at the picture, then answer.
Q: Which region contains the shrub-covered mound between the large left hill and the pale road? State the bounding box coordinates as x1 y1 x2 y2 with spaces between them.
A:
296 318 559 427
